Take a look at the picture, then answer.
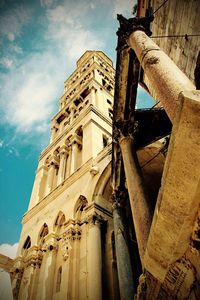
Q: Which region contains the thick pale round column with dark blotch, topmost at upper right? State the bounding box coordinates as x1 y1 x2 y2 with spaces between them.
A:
128 30 195 122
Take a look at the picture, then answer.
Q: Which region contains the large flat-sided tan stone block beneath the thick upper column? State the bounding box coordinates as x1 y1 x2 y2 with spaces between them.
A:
144 90 200 282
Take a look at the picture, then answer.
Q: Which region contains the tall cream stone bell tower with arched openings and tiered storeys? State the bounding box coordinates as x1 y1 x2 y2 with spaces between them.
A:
12 51 118 300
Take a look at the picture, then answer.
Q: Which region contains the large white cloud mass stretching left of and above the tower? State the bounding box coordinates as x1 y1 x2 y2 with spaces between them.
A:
0 1 103 146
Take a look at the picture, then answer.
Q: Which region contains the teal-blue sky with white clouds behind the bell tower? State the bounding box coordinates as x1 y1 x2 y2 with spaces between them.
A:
0 0 153 256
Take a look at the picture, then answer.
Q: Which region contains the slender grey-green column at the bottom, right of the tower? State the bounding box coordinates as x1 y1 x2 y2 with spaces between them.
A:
113 203 134 300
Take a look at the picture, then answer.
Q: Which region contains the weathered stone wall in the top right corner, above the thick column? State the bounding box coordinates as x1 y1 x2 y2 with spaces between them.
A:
152 0 200 81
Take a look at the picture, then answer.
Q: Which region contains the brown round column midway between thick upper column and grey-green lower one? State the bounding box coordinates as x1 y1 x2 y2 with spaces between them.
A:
119 136 152 261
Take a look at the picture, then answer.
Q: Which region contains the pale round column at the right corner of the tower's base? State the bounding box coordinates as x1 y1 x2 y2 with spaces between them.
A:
87 215 102 300
